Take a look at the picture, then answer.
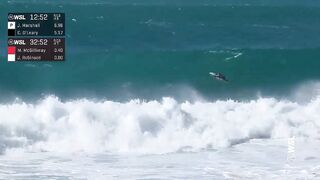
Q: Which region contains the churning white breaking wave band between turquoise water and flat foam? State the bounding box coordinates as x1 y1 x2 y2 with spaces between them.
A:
0 93 320 154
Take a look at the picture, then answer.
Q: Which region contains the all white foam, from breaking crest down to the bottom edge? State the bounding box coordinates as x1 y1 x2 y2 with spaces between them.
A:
0 86 320 179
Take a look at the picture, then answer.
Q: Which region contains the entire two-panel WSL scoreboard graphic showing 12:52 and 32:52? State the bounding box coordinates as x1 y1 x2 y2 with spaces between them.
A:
8 13 65 62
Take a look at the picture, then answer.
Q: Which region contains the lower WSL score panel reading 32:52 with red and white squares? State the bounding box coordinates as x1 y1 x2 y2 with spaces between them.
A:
8 38 65 61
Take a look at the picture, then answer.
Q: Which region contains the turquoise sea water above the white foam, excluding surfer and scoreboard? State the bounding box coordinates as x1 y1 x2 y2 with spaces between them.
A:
0 1 320 100
